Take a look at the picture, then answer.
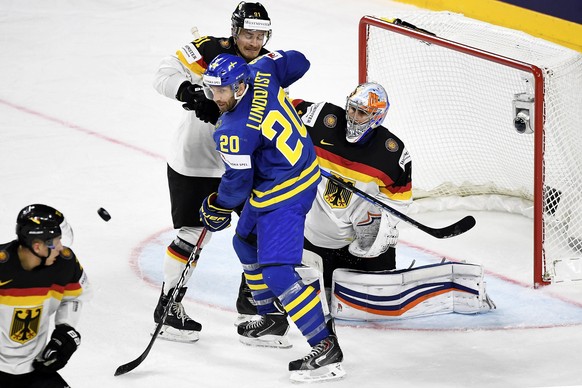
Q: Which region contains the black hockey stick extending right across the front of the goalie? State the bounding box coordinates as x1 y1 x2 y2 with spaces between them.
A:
321 169 475 238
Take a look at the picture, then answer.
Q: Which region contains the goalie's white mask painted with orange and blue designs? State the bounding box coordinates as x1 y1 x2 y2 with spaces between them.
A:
346 82 390 143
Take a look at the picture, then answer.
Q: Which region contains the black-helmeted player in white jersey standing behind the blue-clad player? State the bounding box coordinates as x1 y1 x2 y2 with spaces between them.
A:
149 1 271 342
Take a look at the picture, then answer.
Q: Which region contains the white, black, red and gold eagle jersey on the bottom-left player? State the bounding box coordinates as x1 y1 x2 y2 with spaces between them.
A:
0 241 90 375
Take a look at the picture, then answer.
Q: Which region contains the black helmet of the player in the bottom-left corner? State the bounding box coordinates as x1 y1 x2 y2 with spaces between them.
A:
16 204 73 247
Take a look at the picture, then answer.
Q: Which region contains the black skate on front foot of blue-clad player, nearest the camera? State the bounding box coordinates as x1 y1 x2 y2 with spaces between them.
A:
289 320 346 382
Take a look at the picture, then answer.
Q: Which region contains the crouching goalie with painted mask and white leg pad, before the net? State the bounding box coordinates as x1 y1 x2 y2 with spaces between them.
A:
294 82 495 321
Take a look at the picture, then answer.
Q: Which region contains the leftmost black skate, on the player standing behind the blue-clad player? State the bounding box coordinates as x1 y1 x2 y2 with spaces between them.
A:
154 287 202 342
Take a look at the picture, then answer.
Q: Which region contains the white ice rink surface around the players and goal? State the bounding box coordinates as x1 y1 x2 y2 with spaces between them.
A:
0 0 582 388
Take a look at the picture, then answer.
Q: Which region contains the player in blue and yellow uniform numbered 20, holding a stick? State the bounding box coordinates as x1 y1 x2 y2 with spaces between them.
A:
200 51 345 381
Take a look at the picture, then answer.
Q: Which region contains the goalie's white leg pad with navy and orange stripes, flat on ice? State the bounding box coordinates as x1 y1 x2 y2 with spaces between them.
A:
331 263 495 321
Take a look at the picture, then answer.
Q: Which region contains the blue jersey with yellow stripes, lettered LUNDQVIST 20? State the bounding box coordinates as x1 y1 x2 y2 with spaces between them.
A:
214 51 321 211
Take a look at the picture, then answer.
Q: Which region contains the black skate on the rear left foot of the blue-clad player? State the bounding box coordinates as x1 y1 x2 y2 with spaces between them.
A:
237 312 292 349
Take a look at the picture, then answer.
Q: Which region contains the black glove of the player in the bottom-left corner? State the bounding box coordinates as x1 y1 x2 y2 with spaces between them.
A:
32 325 81 372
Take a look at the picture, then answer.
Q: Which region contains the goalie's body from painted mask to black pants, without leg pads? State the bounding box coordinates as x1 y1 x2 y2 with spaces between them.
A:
294 82 412 288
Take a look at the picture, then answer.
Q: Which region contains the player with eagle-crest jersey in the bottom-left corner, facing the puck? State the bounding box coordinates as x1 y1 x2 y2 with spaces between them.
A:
0 204 89 388
